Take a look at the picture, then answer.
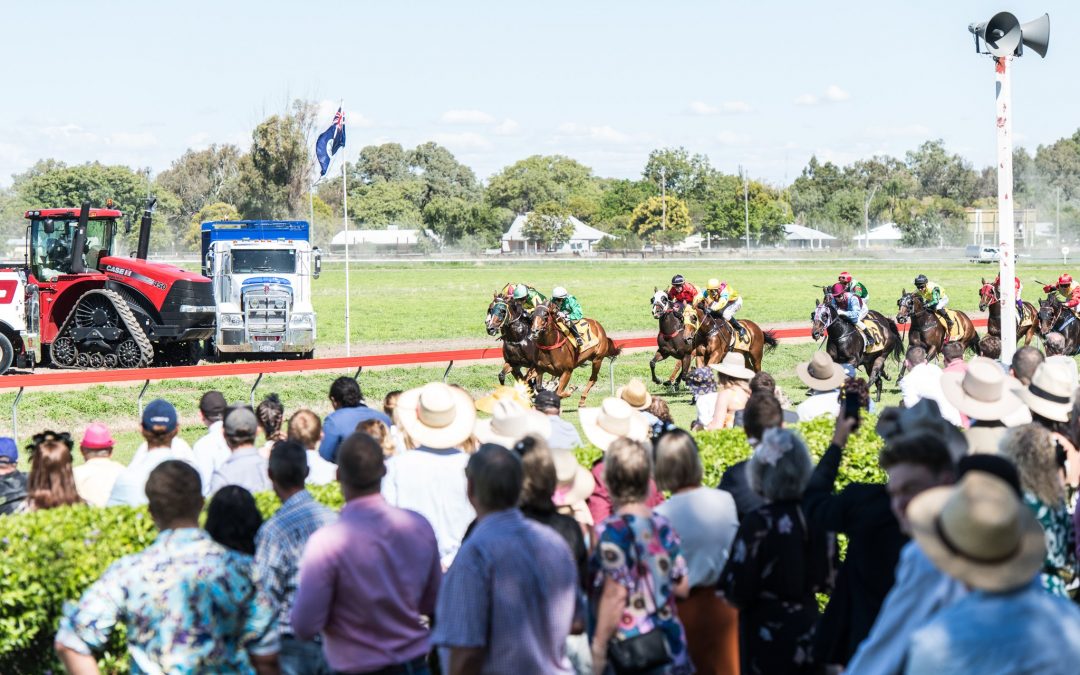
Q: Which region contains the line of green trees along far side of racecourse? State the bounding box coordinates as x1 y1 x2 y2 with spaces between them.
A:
0 100 1080 252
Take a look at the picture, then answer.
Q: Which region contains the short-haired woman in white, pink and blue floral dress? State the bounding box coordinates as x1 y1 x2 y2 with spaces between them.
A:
592 438 693 675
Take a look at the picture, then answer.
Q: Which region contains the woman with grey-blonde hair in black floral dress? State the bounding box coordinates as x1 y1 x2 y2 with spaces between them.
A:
718 429 836 675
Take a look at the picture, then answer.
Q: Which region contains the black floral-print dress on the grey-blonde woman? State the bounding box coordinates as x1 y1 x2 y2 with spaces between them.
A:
718 500 836 675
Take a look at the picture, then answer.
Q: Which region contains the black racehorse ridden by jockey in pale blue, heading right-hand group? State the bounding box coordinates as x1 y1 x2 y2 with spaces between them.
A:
810 300 904 401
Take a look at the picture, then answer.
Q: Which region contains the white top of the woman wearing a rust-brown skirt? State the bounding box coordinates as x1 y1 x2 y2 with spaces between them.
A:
656 487 739 589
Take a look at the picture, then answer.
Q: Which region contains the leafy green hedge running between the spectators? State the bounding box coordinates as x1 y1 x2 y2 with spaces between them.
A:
0 419 885 675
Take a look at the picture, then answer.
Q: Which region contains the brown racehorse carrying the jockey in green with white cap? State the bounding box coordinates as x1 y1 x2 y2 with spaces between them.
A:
531 302 622 406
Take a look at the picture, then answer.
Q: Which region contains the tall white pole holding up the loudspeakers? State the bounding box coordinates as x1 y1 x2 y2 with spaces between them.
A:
994 56 1016 363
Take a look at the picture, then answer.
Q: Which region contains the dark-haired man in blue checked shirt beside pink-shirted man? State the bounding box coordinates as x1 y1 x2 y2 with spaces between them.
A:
255 441 337 675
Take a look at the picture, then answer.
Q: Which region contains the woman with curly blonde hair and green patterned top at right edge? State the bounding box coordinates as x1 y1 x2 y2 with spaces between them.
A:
999 423 1077 597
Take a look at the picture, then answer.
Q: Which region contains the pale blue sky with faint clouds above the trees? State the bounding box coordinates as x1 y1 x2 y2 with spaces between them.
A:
0 0 1080 185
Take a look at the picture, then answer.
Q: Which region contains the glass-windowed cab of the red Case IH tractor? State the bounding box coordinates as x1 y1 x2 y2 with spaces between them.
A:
26 208 122 282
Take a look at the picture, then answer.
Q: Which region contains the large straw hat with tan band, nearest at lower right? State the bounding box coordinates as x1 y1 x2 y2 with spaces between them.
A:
907 471 1047 593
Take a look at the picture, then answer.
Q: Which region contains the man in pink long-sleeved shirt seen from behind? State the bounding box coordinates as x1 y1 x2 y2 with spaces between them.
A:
292 433 443 675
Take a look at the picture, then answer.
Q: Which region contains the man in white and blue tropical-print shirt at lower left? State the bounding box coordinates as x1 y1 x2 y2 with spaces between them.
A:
56 460 278 675
